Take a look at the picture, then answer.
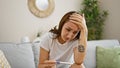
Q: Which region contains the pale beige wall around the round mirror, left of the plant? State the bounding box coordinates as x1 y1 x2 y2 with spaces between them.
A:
0 0 81 42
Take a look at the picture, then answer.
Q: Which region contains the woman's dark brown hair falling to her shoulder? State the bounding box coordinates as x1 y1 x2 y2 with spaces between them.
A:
49 11 80 39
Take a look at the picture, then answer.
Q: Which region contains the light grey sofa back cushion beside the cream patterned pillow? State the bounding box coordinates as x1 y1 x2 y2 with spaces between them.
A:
0 43 35 68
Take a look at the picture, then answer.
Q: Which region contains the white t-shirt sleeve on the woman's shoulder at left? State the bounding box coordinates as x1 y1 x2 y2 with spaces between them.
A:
40 32 53 51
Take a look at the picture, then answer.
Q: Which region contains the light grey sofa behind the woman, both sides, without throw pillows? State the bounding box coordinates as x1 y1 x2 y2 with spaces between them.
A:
0 39 120 68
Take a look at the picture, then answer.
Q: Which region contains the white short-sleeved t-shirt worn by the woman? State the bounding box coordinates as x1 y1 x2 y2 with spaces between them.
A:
40 32 78 68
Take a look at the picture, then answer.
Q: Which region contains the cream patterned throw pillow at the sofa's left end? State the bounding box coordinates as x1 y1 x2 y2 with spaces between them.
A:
0 50 11 68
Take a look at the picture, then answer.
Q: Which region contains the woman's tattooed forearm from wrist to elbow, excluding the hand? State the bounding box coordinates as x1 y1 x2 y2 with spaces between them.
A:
74 31 87 65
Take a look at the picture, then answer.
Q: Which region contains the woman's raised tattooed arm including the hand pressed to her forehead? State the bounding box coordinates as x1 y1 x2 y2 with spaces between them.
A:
70 13 88 65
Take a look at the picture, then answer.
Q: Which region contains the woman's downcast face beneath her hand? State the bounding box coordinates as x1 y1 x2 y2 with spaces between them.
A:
61 21 79 42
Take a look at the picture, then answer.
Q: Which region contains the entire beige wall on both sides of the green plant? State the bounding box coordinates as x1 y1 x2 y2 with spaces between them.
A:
0 0 120 42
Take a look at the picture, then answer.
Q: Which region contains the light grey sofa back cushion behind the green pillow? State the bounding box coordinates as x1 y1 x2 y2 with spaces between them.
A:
84 40 119 68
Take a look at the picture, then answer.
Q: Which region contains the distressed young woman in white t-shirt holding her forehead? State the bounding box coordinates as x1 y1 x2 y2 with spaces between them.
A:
38 11 88 68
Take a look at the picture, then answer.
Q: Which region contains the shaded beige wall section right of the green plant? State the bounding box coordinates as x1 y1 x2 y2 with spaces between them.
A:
100 0 120 41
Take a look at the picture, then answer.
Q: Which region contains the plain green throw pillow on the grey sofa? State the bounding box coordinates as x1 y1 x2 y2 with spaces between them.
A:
96 46 120 68
